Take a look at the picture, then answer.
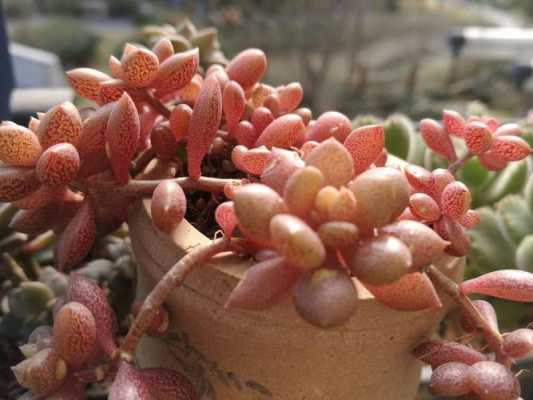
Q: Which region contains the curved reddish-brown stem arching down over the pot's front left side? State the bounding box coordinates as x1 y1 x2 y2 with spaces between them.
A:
119 238 234 362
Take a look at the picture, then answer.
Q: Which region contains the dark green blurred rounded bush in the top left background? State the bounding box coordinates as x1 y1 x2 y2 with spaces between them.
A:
12 17 99 68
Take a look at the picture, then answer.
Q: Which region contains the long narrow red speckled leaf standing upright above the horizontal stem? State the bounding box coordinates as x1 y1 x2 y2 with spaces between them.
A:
187 77 222 179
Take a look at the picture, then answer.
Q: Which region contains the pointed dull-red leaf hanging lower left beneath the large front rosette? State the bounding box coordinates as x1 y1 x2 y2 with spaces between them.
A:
225 257 299 310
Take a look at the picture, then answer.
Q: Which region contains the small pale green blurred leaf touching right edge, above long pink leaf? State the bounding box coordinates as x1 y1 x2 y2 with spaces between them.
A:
496 194 533 244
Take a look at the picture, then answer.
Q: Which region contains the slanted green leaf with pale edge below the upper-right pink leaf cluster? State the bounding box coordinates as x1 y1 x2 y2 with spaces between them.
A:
480 160 528 204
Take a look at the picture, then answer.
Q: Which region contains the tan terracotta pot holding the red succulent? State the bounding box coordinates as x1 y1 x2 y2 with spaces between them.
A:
129 201 464 400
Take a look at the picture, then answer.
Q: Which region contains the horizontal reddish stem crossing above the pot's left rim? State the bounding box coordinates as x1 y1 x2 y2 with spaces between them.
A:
91 177 241 195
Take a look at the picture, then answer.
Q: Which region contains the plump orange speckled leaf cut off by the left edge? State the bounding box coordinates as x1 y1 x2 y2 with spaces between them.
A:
0 125 42 167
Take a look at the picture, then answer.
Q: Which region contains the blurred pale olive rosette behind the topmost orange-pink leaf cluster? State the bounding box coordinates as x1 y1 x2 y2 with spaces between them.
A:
142 19 228 69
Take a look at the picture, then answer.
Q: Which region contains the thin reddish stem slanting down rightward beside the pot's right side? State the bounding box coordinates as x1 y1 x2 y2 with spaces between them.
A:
426 265 510 366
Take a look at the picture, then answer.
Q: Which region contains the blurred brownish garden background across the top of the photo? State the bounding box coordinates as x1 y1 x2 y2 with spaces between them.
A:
3 0 533 118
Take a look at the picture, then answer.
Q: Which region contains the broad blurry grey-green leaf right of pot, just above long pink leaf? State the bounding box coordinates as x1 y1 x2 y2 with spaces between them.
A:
468 207 515 271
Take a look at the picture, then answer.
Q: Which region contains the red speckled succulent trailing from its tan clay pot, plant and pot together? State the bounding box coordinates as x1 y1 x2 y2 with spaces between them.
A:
0 25 533 400
